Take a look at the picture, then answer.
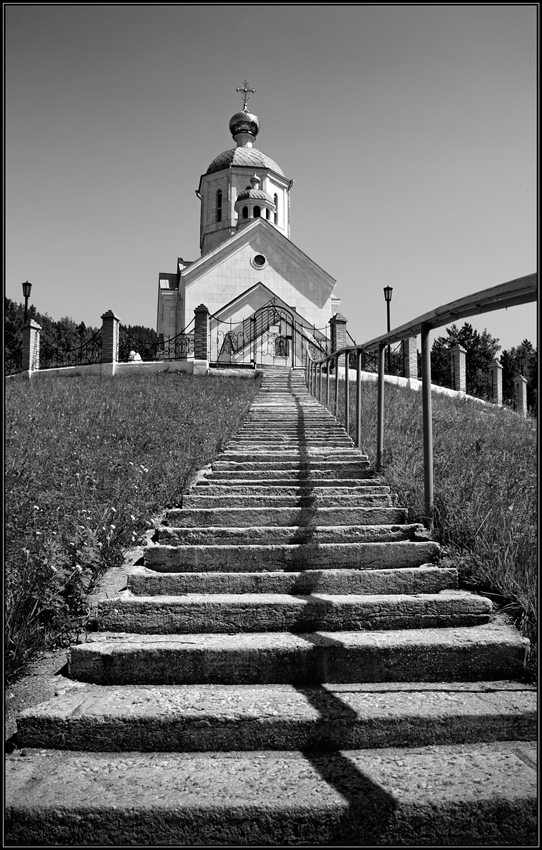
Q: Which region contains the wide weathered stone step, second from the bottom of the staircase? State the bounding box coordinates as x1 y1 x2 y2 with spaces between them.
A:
17 681 538 752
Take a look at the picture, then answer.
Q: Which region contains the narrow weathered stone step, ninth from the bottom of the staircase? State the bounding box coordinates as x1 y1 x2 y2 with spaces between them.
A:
181 492 391 508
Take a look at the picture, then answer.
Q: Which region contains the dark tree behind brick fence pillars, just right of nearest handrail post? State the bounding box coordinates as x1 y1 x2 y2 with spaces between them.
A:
431 322 499 398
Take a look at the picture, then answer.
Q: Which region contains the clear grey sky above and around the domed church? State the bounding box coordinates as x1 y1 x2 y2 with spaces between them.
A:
4 3 538 348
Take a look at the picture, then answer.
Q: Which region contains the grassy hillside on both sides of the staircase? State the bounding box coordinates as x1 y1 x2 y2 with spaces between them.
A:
5 373 537 679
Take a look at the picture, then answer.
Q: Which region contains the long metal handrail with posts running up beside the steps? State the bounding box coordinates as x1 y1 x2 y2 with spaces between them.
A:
305 273 538 527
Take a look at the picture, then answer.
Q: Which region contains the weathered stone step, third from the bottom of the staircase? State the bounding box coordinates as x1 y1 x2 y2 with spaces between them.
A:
68 622 529 685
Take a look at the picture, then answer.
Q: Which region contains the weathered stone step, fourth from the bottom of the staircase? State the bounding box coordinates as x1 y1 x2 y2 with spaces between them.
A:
96 590 492 635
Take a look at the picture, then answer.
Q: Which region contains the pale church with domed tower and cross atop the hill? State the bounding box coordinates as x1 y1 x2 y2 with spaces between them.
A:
157 82 339 366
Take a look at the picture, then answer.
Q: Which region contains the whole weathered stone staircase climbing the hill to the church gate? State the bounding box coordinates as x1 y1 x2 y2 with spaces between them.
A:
6 371 537 846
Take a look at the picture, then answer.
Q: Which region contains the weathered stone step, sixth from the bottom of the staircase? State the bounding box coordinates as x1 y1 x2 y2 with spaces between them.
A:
143 536 440 573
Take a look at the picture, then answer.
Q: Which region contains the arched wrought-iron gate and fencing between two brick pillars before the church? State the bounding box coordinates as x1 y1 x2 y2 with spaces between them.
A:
209 302 329 368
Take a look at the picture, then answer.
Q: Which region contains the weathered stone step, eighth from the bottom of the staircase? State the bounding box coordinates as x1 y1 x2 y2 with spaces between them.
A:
163 505 407 528
